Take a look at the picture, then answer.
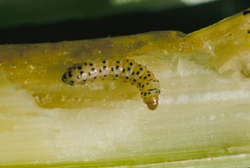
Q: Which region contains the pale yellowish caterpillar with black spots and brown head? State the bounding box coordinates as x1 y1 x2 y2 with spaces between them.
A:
62 59 160 110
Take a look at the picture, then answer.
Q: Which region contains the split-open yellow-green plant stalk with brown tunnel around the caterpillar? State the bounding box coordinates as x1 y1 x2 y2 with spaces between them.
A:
0 7 250 167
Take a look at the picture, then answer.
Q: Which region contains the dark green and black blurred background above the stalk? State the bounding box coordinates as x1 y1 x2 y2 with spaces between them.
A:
0 0 250 44
